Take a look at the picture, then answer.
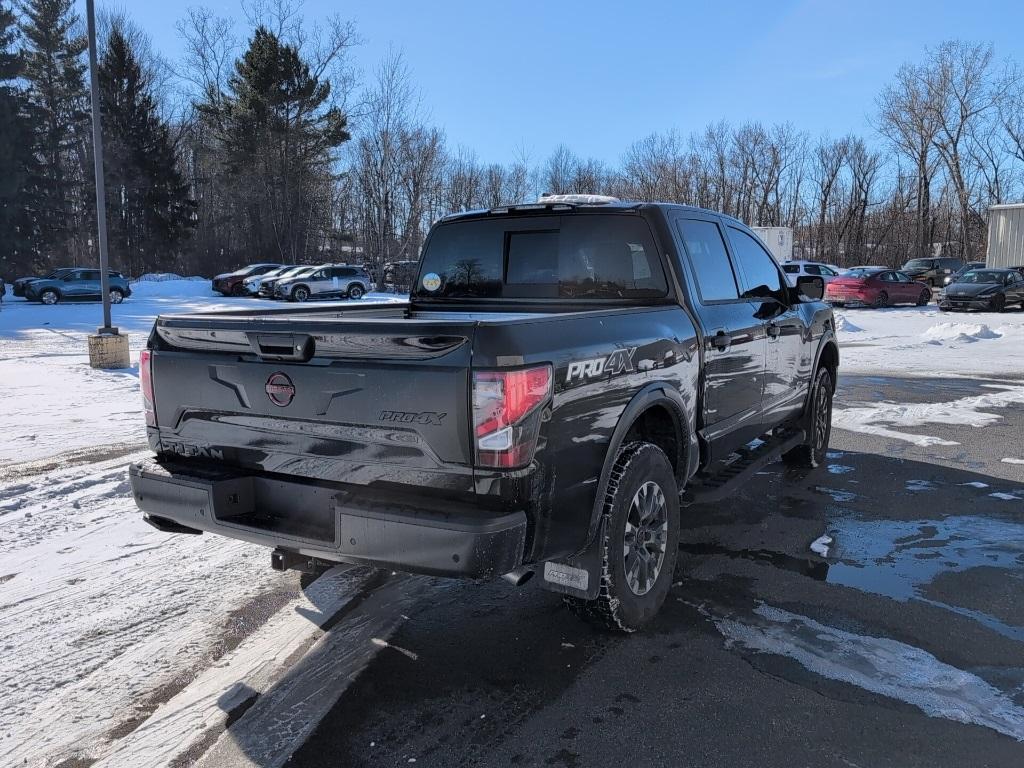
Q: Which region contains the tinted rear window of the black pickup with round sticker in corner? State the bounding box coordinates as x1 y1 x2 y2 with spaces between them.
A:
413 213 668 299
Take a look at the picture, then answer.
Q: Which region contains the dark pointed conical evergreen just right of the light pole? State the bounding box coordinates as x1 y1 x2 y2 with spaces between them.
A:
99 22 195 274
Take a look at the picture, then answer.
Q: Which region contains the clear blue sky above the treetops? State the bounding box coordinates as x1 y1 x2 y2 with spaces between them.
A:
79 0 1024 162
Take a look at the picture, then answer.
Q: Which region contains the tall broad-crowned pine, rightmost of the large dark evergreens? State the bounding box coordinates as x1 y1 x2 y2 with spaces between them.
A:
198 27 349 263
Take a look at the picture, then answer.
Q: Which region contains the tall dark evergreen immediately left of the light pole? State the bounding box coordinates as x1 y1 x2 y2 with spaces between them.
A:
22 0 92 262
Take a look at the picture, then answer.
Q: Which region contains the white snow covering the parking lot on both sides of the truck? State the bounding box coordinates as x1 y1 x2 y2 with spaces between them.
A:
0 281 1024 765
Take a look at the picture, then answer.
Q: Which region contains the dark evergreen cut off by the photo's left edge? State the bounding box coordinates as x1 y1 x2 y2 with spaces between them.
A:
0 2 32 279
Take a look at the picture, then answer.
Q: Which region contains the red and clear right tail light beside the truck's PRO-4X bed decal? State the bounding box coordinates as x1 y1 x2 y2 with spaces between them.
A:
473 366 552 469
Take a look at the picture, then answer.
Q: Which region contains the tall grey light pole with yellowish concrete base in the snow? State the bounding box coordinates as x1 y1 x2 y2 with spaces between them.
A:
85 0 130 368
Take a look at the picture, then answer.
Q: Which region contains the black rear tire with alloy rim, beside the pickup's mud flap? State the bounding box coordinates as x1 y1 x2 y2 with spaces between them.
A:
565 442 679 632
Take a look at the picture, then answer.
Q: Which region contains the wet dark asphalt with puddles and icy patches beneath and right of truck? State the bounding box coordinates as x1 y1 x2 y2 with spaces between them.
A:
287 376 1024 768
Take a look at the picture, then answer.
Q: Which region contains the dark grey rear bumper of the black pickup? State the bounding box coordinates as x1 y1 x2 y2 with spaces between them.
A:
129 459 526 579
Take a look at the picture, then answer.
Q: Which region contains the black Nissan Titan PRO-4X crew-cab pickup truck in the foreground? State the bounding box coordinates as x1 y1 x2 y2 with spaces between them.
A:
130 198 839 630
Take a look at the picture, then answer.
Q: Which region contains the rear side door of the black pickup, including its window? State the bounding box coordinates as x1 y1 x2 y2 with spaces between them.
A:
674 212 766 456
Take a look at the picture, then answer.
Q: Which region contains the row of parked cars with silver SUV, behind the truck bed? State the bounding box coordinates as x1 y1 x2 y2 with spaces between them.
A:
211 264 375 301
